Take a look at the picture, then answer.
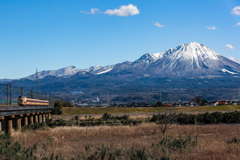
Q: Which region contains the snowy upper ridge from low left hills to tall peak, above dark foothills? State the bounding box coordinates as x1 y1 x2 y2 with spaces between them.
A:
16 42 240 80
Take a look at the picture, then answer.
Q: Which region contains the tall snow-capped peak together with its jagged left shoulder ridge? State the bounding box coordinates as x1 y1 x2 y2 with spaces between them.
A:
106 42 240 77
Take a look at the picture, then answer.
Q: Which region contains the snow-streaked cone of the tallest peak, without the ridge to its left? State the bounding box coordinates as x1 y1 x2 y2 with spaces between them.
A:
142 42 240 77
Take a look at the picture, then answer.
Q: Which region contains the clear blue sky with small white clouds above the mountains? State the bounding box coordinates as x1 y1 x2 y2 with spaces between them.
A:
0 0 240 79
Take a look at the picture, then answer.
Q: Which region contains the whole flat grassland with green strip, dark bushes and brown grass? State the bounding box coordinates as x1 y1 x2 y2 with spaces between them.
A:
1 106 240 160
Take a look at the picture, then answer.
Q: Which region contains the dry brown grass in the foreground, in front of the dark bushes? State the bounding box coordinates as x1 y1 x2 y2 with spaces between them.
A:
13 123 240 160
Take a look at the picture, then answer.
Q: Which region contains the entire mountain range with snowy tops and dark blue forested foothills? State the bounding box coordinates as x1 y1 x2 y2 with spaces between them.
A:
0 42 240 99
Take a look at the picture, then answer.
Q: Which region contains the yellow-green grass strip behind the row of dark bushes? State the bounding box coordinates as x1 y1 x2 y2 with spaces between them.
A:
59 105 240 120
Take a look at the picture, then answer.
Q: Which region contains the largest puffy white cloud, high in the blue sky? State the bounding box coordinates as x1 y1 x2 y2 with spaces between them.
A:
104 3 140 17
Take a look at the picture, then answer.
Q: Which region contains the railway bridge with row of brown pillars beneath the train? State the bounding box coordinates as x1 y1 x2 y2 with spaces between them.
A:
0 106 54 134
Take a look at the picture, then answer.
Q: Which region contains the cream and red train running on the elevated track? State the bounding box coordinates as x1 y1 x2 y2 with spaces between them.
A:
18 96 49 106
